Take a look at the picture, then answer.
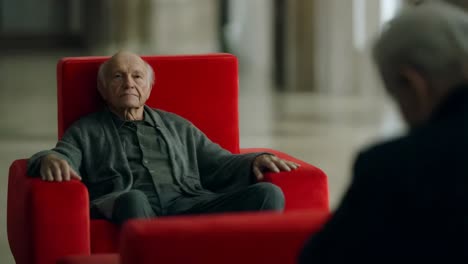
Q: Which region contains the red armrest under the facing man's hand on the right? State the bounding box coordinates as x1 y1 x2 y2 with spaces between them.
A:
241 148 329 211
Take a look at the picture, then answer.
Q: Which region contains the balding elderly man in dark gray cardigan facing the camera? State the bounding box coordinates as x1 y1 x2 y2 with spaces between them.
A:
28 52 299 224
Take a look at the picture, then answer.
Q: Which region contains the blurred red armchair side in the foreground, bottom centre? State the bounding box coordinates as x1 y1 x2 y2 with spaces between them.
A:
120 210 328 264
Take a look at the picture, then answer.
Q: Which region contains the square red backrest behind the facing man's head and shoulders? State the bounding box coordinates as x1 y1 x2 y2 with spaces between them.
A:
57 54 239 153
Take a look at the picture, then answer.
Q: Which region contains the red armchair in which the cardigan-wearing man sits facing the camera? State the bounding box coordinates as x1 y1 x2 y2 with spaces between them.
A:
7 54 329 264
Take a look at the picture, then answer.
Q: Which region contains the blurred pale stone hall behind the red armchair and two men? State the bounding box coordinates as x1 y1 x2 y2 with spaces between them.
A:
0 0 409 263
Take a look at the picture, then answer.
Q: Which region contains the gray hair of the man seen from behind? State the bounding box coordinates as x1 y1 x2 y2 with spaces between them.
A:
373 1 468 87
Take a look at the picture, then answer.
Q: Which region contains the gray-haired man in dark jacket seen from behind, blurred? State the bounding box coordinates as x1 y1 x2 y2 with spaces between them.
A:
299 2 468 263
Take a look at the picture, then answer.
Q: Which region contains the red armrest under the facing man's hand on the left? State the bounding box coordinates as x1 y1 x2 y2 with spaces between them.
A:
7 159 90 264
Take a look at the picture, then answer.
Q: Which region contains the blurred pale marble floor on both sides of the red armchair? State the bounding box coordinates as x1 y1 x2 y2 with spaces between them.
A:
0 50 402 264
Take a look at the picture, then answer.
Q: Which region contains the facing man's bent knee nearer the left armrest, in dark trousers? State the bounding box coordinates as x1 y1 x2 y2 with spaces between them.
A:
112 190 155 224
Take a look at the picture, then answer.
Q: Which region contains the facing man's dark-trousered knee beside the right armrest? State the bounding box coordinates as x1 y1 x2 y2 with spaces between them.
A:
251 182 285 211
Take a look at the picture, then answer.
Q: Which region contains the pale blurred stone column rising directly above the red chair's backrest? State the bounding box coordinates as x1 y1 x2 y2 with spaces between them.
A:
141 0 219 54
